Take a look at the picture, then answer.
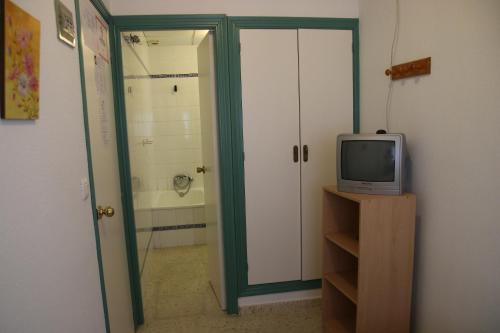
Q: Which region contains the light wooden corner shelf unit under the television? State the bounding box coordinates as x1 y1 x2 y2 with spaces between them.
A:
323 186 416 333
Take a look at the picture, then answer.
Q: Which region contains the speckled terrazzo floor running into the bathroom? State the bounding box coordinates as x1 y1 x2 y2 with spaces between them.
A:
138 245 321 333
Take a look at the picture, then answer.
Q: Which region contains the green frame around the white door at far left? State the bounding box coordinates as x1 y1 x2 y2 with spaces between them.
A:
75 0 115 333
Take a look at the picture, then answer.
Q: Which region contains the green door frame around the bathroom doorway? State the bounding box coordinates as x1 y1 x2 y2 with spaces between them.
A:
112 15 238 325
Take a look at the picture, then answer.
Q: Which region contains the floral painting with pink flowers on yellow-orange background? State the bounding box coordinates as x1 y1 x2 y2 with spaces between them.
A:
1 0 40 119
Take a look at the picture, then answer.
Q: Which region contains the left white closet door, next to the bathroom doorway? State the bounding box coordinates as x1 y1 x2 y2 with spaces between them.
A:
240 30 301 285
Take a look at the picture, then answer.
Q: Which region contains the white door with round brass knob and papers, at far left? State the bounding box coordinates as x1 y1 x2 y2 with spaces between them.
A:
80 0 134 333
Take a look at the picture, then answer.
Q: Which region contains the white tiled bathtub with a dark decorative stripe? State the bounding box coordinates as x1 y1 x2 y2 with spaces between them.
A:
134 188 206 248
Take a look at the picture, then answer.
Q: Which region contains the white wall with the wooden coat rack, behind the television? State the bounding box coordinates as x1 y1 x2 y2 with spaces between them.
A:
360 0 500 333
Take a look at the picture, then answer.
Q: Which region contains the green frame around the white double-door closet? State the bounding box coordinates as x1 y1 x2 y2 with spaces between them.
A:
228 16 359 296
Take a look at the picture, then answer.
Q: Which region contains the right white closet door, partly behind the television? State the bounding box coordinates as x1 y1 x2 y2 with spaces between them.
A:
299 30 353 280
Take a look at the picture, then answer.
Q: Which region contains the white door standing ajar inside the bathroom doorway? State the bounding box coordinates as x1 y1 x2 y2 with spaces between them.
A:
198 32 226 309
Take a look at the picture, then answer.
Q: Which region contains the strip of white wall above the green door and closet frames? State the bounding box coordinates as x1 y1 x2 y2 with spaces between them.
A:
109 0 358 17
